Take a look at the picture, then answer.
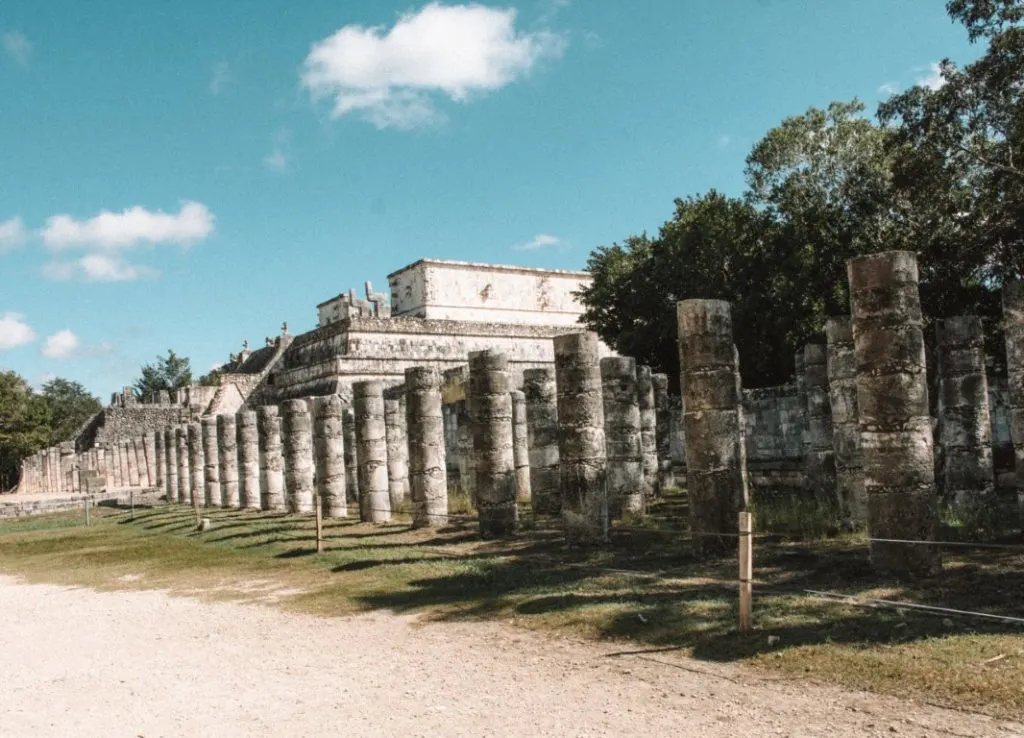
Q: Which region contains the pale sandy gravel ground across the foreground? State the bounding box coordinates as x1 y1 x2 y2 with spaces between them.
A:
0 577 1024 738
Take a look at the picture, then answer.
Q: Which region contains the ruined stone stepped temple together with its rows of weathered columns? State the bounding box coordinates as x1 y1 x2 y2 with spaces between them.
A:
19 252 1024 574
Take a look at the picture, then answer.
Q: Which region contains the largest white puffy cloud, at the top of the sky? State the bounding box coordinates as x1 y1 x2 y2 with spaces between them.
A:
301 2 565 129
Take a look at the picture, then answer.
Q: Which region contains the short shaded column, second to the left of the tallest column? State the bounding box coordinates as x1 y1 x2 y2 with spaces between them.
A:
804 343 837 504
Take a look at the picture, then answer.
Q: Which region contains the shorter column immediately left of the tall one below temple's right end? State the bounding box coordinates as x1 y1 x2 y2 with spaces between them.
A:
522 368 562 515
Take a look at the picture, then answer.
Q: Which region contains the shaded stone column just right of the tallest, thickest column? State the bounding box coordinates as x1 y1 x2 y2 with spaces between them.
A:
935 315 995 508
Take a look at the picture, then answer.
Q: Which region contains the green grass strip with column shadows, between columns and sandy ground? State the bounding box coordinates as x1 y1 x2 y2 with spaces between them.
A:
0 495 1024 719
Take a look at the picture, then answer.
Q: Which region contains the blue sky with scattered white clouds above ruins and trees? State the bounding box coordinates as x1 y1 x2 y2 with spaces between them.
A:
0 0 977 401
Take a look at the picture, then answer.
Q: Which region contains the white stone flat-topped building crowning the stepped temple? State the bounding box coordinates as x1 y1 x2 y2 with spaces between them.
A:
388 260 591 325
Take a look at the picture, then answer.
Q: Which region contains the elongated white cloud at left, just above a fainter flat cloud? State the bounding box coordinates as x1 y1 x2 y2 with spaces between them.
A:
41 202 214 250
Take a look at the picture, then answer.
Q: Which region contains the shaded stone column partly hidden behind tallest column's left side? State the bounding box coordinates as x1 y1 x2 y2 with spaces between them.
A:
825 317 867 528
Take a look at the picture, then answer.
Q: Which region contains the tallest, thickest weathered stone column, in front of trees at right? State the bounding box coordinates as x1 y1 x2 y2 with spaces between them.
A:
847 251 942 575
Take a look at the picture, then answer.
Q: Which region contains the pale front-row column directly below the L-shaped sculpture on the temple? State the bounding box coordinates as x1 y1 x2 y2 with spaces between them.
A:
352 382 391 523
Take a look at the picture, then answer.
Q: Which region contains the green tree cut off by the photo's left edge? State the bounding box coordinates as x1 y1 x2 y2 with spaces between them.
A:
0 372 51 490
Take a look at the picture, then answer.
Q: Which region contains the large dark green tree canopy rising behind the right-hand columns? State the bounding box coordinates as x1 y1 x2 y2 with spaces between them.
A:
580 0 1024 387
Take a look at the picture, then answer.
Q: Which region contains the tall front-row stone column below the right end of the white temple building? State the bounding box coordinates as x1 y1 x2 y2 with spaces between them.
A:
553 333 608 542
